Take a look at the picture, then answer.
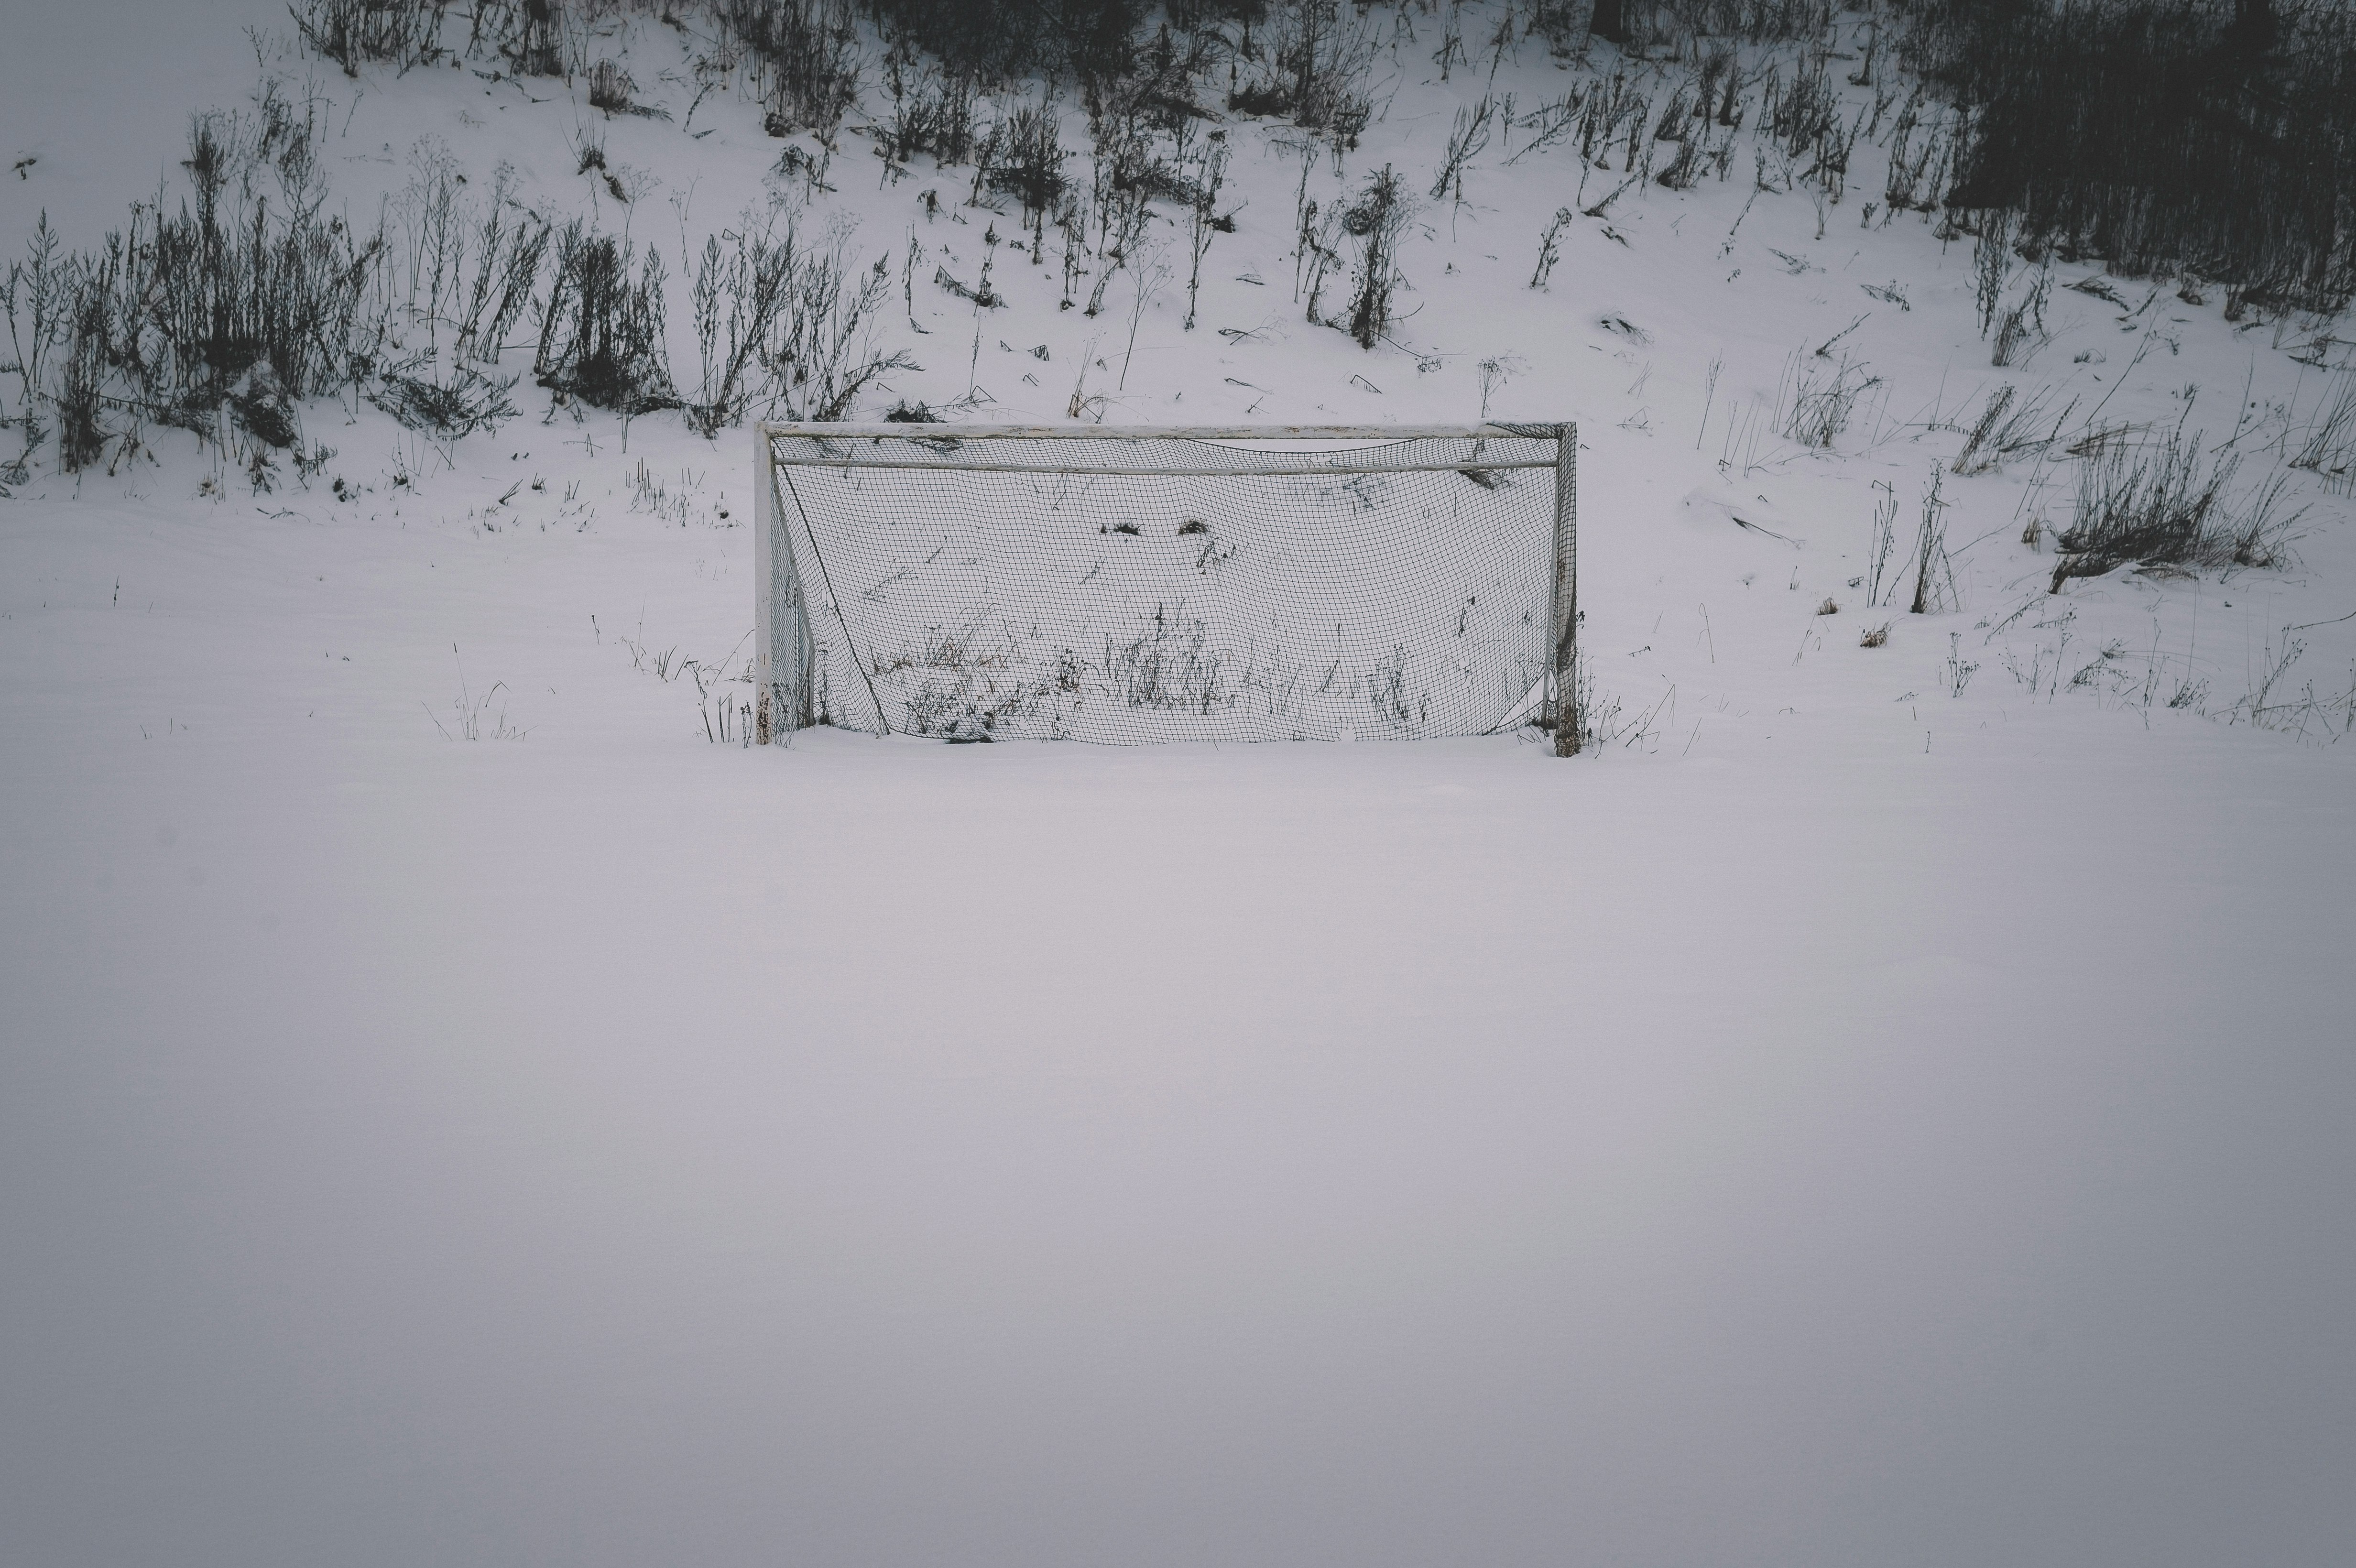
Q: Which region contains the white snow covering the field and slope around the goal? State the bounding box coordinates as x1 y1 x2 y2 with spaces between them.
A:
0 0 2356 1568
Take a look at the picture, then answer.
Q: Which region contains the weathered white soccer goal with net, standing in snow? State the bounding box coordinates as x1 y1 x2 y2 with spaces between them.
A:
754 424 1579 756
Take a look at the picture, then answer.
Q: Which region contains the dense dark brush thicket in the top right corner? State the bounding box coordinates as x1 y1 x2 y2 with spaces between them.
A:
1904 0 2356 320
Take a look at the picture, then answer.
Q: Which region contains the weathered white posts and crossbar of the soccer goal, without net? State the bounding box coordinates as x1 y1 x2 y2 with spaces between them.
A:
754 424 1579 756
